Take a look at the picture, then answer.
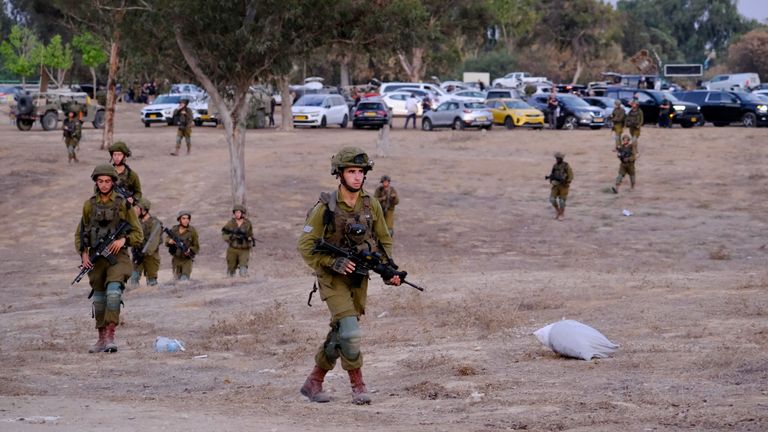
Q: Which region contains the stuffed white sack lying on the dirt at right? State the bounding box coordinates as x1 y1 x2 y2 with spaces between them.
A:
533 320 619 360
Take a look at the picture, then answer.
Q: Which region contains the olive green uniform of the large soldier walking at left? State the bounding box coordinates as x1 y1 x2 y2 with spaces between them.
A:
75 191 144 329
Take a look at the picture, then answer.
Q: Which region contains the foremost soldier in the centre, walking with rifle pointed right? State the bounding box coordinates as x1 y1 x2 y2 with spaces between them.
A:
298 147 400 405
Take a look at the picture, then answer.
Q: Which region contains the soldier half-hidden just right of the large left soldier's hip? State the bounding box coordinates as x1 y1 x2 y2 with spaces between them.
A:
130 198 163 286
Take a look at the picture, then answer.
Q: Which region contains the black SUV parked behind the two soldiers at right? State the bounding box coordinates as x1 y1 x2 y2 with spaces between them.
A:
604 87 703 128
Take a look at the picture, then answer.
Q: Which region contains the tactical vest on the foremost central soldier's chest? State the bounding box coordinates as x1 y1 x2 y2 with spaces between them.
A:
320 191 380 252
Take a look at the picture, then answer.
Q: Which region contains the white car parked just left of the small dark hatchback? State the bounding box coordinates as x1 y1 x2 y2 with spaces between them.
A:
291 94 349 128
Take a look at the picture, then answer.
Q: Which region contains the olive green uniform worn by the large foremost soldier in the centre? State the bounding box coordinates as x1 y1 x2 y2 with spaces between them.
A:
298 186 392 371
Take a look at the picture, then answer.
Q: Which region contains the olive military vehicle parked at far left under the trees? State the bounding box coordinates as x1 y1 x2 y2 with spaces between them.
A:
11 92 106 131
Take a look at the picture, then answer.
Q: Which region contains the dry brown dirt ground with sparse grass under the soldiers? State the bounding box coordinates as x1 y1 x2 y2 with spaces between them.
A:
0 105 768 432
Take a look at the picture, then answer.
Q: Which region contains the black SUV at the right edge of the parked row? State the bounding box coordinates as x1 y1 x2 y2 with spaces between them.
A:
675 90 768 127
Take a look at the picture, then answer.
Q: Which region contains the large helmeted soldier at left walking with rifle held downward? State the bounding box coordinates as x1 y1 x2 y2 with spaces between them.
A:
75 164 144 353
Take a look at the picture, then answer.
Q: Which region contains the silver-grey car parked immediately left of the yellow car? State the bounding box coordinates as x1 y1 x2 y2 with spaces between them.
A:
421 100 493 131
